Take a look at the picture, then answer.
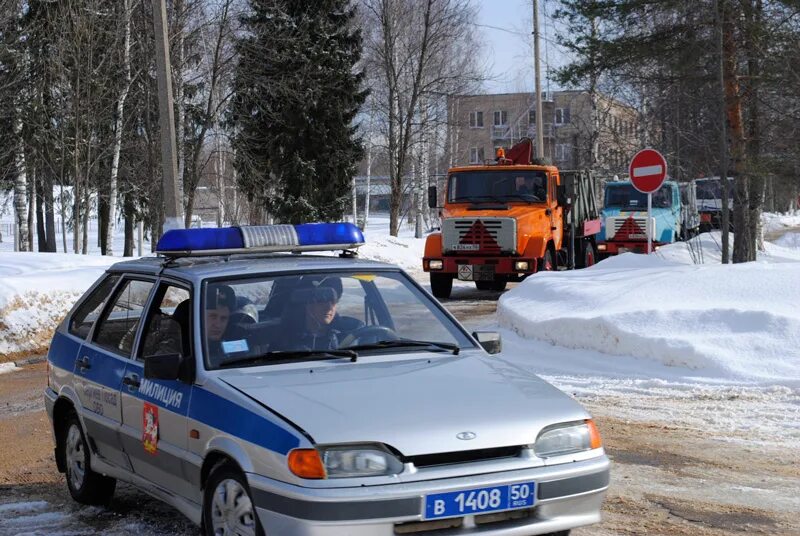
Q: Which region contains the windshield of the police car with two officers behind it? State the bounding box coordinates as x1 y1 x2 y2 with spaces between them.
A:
201 270 474 369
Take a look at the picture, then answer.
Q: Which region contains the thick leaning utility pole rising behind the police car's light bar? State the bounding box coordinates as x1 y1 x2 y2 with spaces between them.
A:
153 0 184 231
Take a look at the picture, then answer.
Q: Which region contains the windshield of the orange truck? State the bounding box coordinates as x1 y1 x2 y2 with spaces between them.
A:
447 170 547 203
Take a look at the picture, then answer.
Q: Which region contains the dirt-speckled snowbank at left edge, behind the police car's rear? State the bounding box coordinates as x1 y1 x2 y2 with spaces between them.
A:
0 253 118 361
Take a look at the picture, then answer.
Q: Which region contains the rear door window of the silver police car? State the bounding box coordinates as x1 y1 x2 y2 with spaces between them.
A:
94 279 153 357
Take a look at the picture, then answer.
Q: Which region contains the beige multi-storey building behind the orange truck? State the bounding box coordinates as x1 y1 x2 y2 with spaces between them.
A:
448 90 640 174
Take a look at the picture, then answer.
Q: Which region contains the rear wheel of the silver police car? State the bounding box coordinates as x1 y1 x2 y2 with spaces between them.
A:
58 412 117 505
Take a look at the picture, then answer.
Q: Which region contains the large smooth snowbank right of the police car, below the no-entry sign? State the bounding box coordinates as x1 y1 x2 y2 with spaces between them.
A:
498 245 800 386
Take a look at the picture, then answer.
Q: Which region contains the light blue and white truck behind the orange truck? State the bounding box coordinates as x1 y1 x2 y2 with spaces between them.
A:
597 180 699 256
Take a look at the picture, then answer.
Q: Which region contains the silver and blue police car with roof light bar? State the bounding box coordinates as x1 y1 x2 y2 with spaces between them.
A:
45 223 609 536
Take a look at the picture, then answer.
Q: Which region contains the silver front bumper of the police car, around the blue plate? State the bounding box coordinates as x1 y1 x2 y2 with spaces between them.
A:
247 455 610 536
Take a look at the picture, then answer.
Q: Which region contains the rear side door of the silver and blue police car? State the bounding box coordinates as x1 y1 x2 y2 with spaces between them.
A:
73 278 153 470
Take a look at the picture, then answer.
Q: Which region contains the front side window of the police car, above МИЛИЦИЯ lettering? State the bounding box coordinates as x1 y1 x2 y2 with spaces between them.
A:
137 283 192 359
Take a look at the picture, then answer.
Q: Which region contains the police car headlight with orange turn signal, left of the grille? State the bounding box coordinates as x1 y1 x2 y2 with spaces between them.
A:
289 445 403 479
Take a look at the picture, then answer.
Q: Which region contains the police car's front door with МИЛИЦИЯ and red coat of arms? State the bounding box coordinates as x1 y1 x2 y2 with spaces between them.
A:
122 281 198 498
